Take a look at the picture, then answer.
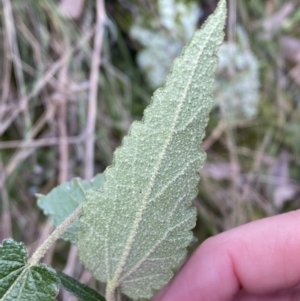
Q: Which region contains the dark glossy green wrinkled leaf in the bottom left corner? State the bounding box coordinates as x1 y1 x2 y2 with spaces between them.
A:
0 239 60 301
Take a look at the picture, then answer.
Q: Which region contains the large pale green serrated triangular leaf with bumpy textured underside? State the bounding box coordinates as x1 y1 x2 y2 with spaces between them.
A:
77 0 226 301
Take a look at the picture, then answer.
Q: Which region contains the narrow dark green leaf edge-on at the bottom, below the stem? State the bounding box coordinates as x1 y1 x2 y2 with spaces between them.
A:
56 271 105 301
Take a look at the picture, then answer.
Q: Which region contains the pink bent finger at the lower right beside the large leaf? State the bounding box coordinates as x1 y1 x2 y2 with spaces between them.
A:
152 210 300 301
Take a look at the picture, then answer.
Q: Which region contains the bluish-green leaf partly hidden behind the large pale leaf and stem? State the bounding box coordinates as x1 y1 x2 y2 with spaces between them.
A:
37 174 102 244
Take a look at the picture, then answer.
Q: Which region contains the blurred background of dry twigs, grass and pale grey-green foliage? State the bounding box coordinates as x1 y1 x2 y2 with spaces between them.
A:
0 0 300 301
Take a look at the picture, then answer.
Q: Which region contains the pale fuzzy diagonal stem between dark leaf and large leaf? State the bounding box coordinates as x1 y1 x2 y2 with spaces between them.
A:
28 206 82 266
